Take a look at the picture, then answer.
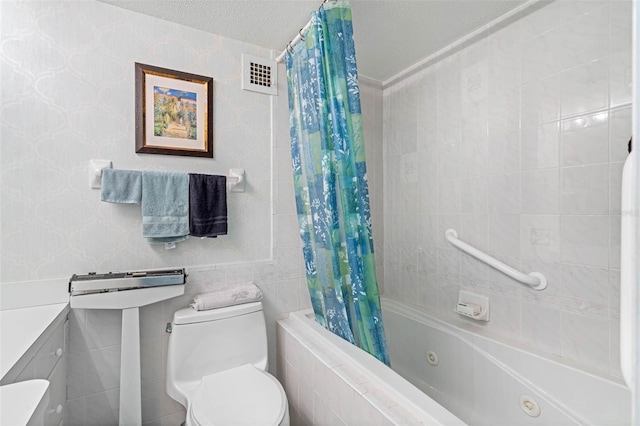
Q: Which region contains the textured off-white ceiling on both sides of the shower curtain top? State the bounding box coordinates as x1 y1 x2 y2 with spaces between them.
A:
100 0 525 81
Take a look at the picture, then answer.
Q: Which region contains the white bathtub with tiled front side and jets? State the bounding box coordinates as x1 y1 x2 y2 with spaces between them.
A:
278 298 631 426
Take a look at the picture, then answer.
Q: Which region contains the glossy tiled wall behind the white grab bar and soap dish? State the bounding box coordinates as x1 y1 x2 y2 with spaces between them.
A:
384 0 631 377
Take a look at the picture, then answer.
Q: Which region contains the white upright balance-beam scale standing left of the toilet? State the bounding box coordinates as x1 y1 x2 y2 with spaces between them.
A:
69 269 187 426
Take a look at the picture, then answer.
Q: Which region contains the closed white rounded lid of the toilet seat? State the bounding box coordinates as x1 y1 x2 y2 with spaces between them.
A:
191 364 287 426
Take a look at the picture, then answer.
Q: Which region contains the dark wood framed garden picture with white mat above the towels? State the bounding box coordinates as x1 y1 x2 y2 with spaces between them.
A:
136 62 213 158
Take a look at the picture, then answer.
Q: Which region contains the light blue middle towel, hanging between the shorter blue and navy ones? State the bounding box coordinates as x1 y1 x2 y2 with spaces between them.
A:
142 171 189 243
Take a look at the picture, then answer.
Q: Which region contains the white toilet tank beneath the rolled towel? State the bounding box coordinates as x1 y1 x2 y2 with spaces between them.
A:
167 302 267 387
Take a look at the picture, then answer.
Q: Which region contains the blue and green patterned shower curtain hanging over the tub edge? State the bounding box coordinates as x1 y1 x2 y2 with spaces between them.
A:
285 1 389 364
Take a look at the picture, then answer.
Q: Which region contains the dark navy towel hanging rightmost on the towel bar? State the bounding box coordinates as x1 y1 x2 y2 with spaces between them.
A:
189 173 227 238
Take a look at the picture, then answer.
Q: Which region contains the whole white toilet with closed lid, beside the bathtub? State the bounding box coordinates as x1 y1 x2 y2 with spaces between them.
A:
167 302 289 426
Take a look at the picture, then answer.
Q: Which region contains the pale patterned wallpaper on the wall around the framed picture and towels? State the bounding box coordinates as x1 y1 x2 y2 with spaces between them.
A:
0 1 272 283
